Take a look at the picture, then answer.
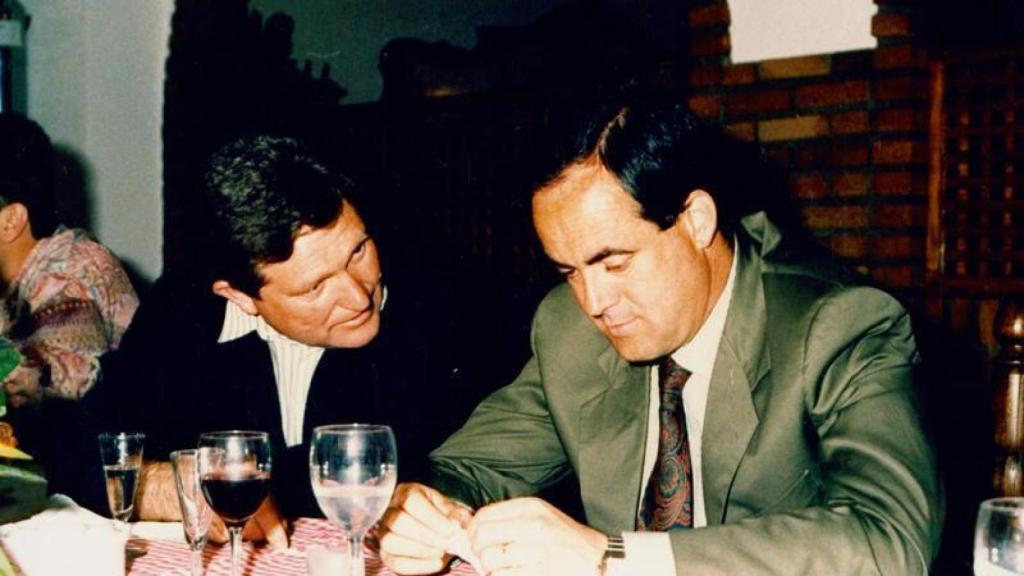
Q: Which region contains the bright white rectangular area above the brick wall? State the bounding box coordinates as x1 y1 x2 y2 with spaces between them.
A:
728 0 878 64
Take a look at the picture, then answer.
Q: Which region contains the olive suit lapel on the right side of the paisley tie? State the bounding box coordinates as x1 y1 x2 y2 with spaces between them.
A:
700 226 771 525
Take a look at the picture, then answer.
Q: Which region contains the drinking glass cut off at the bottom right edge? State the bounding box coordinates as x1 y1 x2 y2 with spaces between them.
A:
974 498 1024 576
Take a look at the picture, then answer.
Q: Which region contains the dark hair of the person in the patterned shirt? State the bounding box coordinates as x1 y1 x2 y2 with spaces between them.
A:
0 112 57 238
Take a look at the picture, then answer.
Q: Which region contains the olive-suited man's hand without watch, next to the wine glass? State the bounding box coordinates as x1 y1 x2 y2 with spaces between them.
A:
379 484 473 574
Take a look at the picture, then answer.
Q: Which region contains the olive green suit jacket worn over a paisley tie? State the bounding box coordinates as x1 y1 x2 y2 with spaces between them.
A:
431 214 942 575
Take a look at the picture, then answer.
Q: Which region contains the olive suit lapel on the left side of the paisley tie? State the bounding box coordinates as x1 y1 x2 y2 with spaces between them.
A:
579 345 650 532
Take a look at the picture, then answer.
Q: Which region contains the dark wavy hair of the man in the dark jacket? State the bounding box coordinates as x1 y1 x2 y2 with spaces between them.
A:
206 135 354 296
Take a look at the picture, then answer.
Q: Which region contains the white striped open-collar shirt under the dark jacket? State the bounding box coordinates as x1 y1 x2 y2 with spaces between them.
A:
217 300 324 446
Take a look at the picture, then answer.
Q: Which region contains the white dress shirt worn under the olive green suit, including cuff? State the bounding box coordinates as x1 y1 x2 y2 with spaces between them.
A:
608 251 736 576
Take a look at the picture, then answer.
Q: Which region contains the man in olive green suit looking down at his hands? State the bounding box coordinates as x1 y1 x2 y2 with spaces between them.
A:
381 100 942 576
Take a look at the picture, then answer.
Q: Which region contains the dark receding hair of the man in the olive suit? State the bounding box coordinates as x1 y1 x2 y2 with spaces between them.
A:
565 98 764 238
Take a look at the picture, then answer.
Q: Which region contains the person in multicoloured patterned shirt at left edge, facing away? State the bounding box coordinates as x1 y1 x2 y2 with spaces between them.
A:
0 113 138 407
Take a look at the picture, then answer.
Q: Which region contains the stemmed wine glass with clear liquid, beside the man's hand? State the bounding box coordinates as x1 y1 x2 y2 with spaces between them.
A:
309 424 398 576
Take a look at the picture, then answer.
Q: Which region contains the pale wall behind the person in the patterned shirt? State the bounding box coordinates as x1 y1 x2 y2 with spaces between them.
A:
19 0 173 280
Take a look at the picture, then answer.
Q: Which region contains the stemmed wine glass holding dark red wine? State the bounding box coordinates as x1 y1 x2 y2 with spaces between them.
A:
199 430 270 576
